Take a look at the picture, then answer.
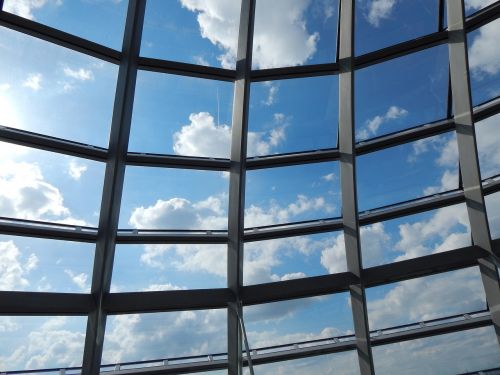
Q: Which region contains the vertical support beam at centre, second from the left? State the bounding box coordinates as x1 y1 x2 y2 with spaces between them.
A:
227 0 255 375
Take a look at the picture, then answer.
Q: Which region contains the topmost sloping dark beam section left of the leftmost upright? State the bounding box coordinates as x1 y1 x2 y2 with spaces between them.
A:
0 11 121 64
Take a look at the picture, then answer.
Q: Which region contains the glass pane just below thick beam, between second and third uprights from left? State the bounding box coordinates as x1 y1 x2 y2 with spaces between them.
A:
243 293 353 352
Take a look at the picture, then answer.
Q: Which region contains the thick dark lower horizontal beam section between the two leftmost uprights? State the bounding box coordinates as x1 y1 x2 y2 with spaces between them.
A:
103 288 235 315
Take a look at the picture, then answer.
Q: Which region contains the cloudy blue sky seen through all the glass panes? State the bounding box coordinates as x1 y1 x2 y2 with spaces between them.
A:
0 0 500 374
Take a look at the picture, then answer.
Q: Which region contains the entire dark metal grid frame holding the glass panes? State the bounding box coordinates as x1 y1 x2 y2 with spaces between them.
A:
0 0 500 375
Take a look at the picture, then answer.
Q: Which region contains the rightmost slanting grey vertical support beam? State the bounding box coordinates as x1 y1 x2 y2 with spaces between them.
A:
447 0 500 344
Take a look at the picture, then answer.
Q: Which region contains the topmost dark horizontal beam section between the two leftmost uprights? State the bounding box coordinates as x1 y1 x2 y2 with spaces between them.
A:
138 57 236 82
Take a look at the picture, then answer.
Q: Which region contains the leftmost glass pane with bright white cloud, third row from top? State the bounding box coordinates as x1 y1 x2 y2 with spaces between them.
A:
0 142 105 226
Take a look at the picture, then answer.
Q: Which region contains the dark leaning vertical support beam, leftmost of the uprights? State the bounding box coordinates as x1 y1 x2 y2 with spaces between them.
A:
82 0 146 375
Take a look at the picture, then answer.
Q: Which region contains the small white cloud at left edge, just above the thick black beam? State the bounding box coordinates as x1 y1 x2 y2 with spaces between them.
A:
0 241 38 290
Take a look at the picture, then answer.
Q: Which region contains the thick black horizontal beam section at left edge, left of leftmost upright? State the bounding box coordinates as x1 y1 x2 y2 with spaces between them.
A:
0 291 94 315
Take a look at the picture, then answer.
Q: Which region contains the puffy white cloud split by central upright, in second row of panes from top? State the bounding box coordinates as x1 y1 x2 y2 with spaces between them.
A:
173 112 287 158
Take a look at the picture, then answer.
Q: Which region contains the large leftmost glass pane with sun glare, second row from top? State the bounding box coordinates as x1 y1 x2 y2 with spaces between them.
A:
0 26 118 147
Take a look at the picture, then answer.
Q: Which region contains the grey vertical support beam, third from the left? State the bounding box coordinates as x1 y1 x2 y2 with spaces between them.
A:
339 0 375 375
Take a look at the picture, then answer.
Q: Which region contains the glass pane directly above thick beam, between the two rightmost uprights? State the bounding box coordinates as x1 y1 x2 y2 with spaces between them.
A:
360 204 471 267
